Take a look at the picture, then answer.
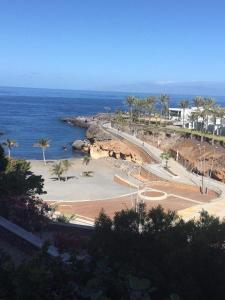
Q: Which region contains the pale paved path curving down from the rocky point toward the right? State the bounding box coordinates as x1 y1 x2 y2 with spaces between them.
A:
101 123 225 220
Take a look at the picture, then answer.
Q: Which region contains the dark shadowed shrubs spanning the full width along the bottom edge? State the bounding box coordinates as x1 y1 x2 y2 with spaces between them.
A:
0 205 225 300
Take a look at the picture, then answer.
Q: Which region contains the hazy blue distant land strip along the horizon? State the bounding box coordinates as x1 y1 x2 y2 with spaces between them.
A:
0 81 225 97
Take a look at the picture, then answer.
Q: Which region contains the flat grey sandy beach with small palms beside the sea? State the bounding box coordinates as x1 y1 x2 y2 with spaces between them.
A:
30 158 135 201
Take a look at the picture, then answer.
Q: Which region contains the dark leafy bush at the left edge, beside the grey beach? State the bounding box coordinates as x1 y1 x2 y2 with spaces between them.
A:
0 147 51 231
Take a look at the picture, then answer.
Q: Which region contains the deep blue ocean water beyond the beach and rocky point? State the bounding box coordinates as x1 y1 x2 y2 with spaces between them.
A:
0 87 225 159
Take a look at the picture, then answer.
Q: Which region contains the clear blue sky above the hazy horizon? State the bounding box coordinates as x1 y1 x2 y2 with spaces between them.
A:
0 0 225 90
